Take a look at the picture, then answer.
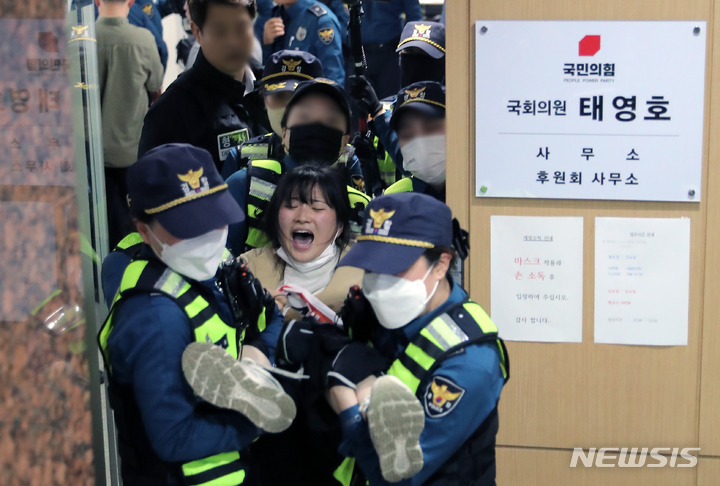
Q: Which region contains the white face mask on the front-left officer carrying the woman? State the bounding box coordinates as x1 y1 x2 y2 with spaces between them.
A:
148 226 228 281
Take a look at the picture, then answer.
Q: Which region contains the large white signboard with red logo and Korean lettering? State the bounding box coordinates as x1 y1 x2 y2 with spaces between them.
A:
475 20 706 202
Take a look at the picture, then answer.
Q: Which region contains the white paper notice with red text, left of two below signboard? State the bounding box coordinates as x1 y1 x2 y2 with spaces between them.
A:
490 216 583 343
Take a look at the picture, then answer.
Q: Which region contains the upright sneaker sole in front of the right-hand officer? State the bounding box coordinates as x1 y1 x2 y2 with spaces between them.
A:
367 376 425 483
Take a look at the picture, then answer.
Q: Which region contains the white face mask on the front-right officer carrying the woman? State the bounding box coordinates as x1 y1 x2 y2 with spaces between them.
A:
362 267 440 329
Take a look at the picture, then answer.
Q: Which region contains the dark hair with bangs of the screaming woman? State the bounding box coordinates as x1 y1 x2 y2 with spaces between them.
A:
265 163 352 251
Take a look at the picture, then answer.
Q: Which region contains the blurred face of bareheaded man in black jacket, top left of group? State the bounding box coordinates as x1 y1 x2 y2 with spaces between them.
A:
191 4 253 77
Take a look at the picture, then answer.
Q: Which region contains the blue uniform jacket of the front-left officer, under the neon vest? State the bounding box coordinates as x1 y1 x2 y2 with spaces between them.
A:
108 245 282 470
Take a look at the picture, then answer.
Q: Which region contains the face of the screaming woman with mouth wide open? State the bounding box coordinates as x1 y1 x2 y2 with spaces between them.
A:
278 187 342 263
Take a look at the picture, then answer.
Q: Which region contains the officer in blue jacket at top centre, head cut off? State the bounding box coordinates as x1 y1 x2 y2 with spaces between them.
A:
262 0 345 86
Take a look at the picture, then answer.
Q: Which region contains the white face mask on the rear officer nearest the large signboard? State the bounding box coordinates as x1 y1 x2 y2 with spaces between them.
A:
400 135 446 185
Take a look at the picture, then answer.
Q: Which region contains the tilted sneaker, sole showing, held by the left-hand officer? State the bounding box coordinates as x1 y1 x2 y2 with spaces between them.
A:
182 342 297 433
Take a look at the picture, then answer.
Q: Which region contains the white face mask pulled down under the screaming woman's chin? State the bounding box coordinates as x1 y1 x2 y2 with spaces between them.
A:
277 230 340 294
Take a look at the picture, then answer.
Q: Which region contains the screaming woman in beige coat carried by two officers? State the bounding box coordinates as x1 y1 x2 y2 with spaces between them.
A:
242 164 363 486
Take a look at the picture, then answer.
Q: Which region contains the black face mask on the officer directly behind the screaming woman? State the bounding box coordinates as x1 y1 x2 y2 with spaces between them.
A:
288 123 344 165
